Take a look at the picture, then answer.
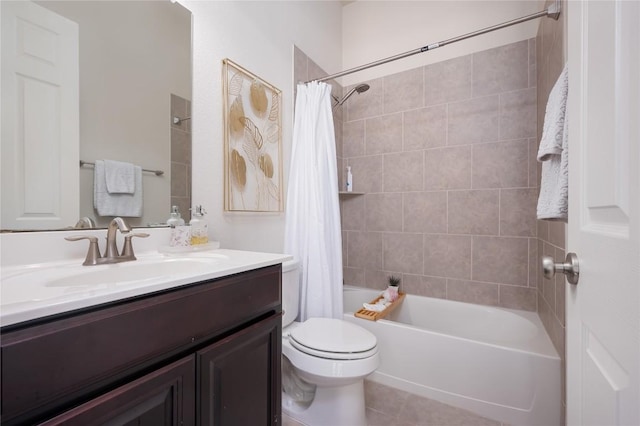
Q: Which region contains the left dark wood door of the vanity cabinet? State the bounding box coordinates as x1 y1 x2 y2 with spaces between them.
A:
42 355 196 426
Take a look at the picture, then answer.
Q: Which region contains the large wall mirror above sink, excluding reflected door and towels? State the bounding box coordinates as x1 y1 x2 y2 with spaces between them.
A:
1 0 191 231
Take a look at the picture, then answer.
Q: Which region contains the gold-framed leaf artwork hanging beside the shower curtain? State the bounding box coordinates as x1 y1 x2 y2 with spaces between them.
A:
222 59 283 212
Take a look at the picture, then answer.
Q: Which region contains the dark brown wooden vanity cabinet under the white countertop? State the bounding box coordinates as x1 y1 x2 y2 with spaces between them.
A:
0 265 282 426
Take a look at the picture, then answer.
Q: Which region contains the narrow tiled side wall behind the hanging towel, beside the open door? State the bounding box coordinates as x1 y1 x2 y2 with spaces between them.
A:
534 2 567 420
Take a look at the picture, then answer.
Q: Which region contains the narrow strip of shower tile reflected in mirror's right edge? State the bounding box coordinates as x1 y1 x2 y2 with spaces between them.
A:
171 94 191 223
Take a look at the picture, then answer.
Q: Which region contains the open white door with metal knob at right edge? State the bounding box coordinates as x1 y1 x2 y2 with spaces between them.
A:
567 0 640 426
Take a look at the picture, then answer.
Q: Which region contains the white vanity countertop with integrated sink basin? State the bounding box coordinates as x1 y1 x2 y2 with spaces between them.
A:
0 249 292 326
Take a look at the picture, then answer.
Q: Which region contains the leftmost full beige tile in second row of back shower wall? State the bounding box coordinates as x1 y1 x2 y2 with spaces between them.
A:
364 113 402 155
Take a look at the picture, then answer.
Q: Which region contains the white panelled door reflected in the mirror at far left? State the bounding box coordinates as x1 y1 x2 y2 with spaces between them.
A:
0 1 80 229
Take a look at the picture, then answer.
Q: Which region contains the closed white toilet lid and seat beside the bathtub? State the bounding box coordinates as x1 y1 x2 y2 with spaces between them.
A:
289 318 378 359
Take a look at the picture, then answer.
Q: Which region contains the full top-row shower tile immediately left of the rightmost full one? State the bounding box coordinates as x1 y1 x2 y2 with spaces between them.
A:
424 55 471 105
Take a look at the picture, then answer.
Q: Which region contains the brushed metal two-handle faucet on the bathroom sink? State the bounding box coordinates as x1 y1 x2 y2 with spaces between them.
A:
65 217 149 266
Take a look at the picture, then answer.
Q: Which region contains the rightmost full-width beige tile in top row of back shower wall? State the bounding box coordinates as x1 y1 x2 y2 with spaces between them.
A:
472 40 529 96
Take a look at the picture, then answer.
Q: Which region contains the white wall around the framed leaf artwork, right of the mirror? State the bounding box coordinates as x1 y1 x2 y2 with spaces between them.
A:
182 0 342 252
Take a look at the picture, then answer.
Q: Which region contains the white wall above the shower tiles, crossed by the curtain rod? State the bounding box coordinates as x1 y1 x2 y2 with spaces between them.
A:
342 0 547 86
